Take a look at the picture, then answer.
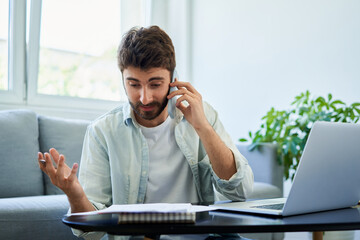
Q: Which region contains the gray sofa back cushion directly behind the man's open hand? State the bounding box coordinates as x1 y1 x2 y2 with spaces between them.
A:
38 115 89 195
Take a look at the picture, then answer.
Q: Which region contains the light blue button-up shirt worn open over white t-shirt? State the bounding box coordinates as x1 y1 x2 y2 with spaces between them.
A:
79 102 253 212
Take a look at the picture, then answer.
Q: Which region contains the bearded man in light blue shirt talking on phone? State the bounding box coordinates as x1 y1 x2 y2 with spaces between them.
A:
38 26 253 239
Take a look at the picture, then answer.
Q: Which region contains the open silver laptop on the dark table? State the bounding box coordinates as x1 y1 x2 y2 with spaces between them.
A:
213 122 360 216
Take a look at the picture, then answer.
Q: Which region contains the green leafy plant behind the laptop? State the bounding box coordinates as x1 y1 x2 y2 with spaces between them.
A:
239 91 360 180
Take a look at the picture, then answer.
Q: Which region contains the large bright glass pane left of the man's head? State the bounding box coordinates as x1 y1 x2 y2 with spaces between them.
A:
36 0 124 101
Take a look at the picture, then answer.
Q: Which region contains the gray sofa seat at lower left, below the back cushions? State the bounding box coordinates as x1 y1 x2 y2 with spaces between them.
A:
0 195 78 239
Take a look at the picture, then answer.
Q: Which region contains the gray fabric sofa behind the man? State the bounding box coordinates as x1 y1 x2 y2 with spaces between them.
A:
0 110 282 239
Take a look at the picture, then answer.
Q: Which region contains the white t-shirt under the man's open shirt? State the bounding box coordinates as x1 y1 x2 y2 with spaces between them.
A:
141 117 199 203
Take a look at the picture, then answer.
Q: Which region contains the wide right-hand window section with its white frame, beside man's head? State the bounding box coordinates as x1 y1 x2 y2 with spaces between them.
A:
26 0 144 112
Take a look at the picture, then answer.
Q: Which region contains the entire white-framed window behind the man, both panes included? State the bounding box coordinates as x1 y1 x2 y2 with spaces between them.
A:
0 0 189 118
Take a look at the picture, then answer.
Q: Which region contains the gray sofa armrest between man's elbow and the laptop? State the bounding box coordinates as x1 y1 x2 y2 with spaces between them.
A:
236 143 284 193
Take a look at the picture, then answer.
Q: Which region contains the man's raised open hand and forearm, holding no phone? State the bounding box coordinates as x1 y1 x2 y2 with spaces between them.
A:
38 148 95 212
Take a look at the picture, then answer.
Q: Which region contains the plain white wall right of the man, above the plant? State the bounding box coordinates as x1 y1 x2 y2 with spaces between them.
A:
192 0 360 140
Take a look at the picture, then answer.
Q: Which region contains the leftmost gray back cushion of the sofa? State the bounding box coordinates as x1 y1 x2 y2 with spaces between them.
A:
0 110 44 198
